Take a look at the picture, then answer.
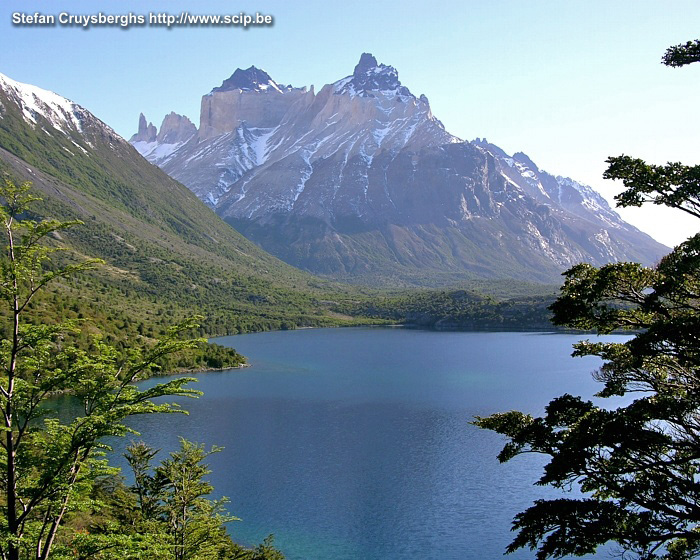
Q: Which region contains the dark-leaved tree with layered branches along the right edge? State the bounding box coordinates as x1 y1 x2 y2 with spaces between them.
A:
475 41 700 560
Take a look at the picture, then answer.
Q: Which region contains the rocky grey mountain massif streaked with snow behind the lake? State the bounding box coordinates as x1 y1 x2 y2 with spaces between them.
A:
130 53 668 285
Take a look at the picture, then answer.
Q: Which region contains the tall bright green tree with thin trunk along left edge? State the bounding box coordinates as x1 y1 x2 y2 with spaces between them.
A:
0 180 200 560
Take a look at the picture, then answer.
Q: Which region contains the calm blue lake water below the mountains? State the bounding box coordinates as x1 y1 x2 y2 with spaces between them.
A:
121 328 620 560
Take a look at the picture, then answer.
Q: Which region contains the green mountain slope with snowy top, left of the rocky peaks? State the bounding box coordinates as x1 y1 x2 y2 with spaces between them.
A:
0 74 364 337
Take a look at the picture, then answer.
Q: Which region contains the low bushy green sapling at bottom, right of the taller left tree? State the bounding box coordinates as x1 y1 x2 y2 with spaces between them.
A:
50 439 284 560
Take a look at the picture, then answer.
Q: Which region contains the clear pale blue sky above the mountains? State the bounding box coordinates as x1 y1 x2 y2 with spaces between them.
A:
0 0 700 245
